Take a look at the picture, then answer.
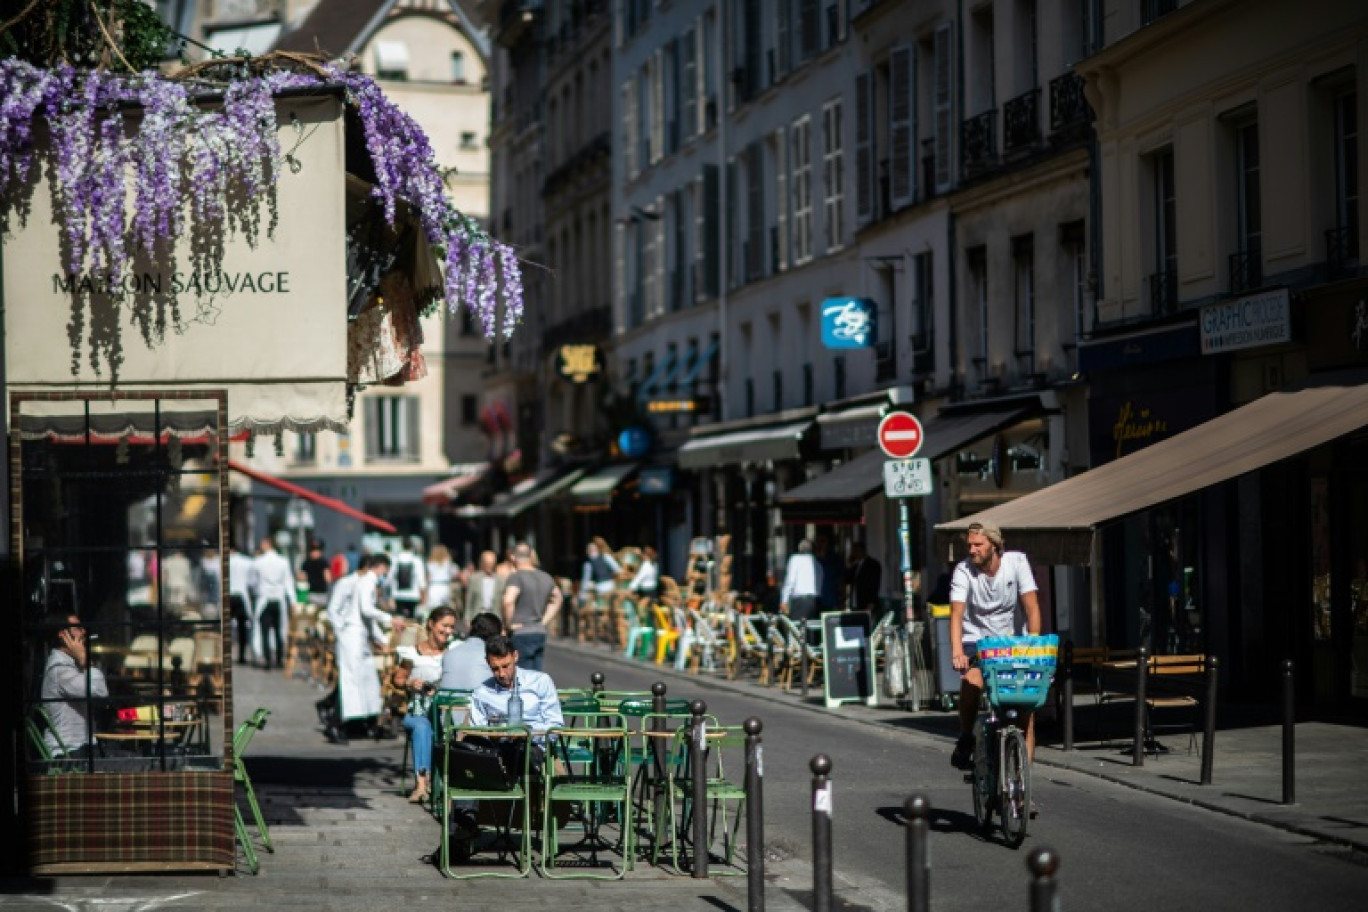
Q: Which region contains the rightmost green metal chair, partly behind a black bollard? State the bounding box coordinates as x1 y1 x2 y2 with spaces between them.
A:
662 721 746 875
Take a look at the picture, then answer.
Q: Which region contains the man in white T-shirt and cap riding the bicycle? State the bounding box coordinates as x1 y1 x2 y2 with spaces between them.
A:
949 521 1040 770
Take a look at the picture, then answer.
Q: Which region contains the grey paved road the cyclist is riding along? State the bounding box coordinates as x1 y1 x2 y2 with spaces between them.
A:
547 648 1368 912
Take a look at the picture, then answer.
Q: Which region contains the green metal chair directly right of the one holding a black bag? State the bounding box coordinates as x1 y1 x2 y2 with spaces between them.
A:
542 712 635 881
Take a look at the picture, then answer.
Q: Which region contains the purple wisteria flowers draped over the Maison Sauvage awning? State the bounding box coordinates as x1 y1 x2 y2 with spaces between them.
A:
0 57 523 369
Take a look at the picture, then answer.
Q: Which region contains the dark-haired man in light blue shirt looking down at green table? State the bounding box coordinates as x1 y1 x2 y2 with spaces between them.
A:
451 634 565 857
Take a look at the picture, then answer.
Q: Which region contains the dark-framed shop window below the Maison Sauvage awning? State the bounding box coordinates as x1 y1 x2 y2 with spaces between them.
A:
11 395 231 776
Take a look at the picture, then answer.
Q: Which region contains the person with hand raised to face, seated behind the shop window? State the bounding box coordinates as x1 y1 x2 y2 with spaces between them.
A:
40 614 109 757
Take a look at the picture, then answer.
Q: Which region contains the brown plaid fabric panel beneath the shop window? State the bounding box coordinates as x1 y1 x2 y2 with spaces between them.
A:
29 771 235 868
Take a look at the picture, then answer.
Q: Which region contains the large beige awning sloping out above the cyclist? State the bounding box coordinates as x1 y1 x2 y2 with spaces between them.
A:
936 383 1368 563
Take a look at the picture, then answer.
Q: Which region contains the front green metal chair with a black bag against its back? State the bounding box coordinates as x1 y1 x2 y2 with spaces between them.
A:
434 725 532 881
